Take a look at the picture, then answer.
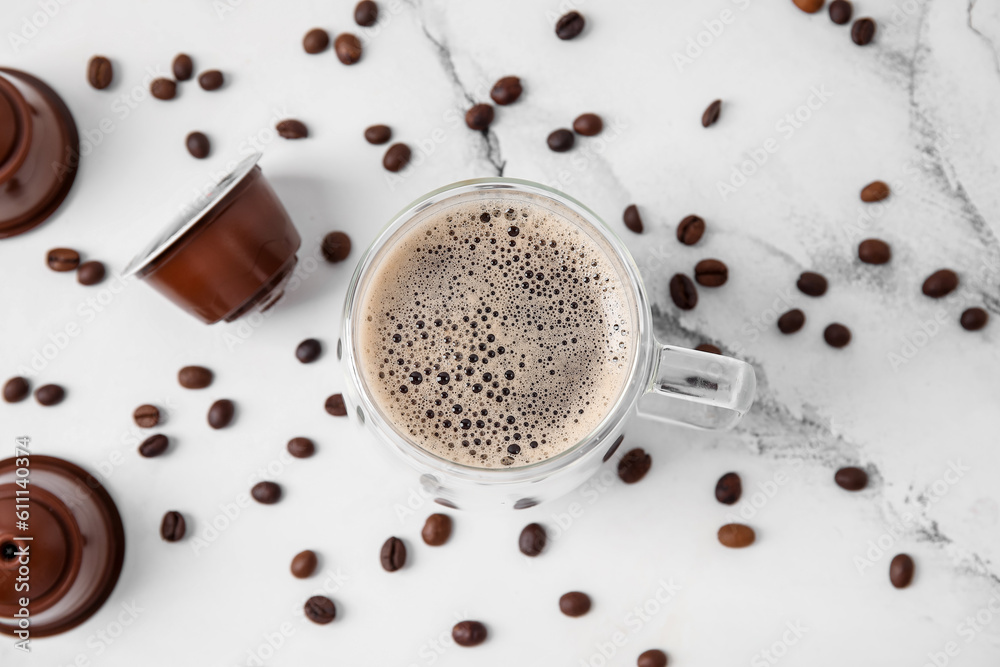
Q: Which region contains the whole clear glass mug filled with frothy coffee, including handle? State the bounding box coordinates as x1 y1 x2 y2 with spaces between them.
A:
337 178 756 509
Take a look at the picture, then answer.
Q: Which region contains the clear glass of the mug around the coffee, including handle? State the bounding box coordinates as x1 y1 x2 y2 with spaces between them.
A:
337 178 756 509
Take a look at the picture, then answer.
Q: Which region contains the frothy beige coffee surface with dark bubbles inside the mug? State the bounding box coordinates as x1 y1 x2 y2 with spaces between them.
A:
358 193 635 468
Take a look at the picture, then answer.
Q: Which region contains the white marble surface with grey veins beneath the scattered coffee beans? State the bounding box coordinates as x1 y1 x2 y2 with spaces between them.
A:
0 0 1000 667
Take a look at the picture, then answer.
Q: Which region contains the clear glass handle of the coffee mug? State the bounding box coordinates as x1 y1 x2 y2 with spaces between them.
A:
639 345 757 430
